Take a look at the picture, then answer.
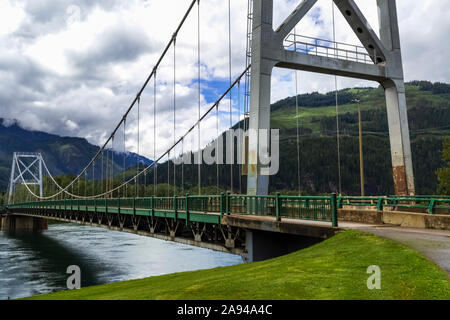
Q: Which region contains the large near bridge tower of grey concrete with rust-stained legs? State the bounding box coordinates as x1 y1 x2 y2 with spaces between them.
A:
247 0 415 195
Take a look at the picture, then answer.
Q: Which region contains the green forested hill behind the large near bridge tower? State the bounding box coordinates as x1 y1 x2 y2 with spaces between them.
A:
149 81 450 195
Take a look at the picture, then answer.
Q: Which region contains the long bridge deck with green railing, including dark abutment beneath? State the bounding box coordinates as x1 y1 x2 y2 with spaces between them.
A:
2 194 339 261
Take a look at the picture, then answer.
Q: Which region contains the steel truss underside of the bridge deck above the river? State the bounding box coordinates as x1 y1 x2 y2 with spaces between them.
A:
7 207 245 255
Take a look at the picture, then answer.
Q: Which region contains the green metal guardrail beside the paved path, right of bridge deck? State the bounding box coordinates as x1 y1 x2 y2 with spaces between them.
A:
337 196 450 214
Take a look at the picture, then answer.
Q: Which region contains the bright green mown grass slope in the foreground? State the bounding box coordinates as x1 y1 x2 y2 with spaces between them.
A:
24 231 450 300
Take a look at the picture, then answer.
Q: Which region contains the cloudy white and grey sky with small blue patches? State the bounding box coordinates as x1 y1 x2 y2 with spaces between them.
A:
0 0 450 158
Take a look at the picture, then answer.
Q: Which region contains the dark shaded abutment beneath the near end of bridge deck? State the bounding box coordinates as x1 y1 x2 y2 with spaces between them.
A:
244 230 324 262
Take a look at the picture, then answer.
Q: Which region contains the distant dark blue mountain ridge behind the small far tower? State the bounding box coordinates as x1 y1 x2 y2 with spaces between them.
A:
0 118 152 190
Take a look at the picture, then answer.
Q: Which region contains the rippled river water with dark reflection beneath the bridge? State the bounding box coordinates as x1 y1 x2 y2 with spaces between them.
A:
0 223 242 300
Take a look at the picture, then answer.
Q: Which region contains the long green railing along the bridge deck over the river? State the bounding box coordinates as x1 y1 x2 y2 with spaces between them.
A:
7 194 338 227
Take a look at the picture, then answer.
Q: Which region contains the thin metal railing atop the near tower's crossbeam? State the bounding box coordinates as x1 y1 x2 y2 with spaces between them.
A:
284 33 381 64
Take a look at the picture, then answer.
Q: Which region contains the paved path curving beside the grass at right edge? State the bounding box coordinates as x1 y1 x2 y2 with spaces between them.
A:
339 222 450 274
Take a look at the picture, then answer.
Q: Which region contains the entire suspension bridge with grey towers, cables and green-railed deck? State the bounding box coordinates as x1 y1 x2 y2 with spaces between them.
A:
2 0 450 261
